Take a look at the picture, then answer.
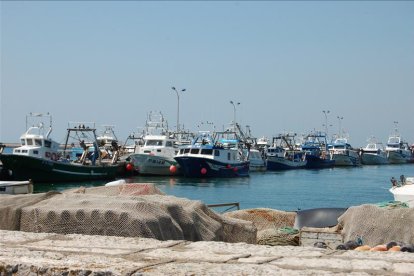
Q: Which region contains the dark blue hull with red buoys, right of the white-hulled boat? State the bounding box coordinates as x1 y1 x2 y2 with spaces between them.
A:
175 156 249 178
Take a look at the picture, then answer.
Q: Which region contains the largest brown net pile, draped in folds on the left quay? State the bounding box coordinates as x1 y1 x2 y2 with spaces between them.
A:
4 184 256 243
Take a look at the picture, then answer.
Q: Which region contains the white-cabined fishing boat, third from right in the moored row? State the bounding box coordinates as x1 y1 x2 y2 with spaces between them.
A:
328 135 361 166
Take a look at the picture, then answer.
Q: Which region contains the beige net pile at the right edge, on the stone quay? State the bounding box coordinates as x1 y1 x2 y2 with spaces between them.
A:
338 204 414 246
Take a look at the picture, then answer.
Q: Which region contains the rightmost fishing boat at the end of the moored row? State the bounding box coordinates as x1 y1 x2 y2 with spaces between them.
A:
385 128 412 164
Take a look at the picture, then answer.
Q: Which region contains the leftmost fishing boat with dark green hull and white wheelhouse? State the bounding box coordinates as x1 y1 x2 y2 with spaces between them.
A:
0 113 124 183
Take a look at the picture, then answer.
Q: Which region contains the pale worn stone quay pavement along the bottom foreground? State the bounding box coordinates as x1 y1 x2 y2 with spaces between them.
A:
0 230 414 275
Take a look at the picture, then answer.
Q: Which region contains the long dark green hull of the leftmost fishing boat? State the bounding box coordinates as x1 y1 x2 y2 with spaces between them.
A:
0 154 121 183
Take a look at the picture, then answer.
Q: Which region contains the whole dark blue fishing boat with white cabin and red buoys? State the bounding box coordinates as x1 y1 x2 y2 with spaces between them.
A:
175 131 250 178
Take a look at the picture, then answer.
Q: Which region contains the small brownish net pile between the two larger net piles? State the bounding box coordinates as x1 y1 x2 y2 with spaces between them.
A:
224 208 299 245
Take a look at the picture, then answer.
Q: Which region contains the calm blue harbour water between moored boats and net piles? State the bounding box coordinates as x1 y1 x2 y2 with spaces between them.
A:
35 164 414 210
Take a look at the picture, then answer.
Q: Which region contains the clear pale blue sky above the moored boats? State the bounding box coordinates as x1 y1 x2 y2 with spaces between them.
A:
0 1 414 147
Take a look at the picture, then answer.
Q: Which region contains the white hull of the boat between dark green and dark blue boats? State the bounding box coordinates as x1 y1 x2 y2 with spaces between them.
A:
130 154 181 175
